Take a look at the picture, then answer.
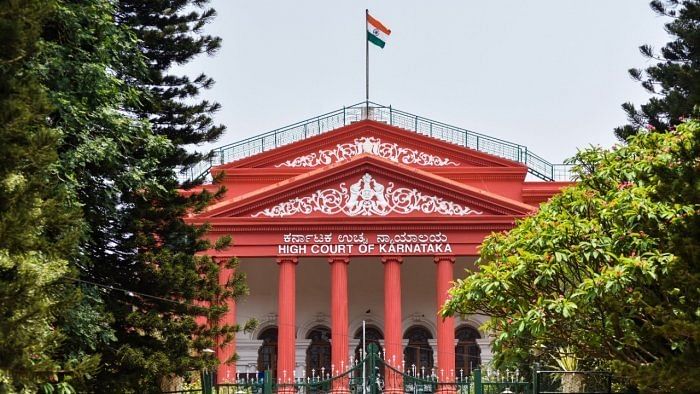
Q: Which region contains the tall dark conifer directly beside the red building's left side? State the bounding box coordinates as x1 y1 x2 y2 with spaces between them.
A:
74 0 246 392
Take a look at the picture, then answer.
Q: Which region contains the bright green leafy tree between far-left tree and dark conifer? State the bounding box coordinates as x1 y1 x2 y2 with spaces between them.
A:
31 0 189 392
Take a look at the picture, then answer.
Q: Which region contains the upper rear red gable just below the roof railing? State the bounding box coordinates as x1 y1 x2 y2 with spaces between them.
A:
214 120 523 171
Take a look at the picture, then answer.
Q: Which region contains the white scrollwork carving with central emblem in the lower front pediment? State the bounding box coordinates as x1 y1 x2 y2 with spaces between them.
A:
251 173 483 217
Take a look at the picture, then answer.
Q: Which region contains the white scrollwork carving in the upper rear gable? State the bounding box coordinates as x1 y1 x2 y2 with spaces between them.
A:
275 137 459 167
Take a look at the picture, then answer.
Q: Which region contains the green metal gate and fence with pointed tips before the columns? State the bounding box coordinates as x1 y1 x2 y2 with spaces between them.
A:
168 344 624 394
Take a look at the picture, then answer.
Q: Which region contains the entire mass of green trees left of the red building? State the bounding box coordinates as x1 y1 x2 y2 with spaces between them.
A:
0 0 246 393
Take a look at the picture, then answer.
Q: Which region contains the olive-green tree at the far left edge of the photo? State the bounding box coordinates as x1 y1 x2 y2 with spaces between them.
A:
0 0 98 392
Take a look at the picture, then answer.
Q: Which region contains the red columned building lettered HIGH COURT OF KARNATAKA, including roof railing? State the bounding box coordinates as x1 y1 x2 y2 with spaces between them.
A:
187 103 569 382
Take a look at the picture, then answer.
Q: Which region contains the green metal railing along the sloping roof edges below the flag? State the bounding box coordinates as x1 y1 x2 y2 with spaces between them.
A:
177 101 574 183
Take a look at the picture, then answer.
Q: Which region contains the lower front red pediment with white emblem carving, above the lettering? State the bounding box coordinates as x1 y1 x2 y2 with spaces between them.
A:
197 153 535 220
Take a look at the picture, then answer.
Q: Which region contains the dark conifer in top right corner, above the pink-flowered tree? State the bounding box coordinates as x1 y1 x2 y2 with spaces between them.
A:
615 0 700 140
